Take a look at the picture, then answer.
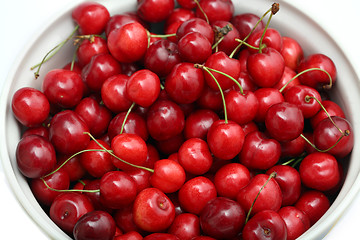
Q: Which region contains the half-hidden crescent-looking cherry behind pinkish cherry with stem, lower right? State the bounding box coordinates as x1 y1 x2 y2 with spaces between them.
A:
266 165 302 206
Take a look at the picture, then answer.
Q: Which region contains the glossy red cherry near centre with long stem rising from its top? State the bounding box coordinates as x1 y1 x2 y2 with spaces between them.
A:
207 120 245 160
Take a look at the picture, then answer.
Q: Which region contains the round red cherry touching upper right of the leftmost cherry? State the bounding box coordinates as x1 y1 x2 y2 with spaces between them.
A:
42 69 84 108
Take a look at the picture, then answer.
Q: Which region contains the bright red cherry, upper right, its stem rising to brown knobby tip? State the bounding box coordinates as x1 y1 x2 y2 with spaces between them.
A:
247 47 285 88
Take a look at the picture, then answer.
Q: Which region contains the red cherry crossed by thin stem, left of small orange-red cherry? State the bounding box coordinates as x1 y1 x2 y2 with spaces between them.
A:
80 139 115 178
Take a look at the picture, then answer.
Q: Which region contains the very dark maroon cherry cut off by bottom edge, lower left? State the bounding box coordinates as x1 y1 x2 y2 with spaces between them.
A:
73 211 116 240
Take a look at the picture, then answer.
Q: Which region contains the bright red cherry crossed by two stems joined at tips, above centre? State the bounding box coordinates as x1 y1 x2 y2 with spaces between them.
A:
204 52 240 91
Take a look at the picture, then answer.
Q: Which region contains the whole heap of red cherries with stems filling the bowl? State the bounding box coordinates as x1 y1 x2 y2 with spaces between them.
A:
12 0 354 240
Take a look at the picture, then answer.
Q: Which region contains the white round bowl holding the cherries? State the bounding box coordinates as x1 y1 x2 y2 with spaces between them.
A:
0 0 360 239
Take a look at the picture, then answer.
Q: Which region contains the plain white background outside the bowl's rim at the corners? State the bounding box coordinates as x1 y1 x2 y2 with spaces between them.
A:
0 0 360 240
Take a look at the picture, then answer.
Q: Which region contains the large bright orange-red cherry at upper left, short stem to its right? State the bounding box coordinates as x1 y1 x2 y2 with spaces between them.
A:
107 22 148 63
